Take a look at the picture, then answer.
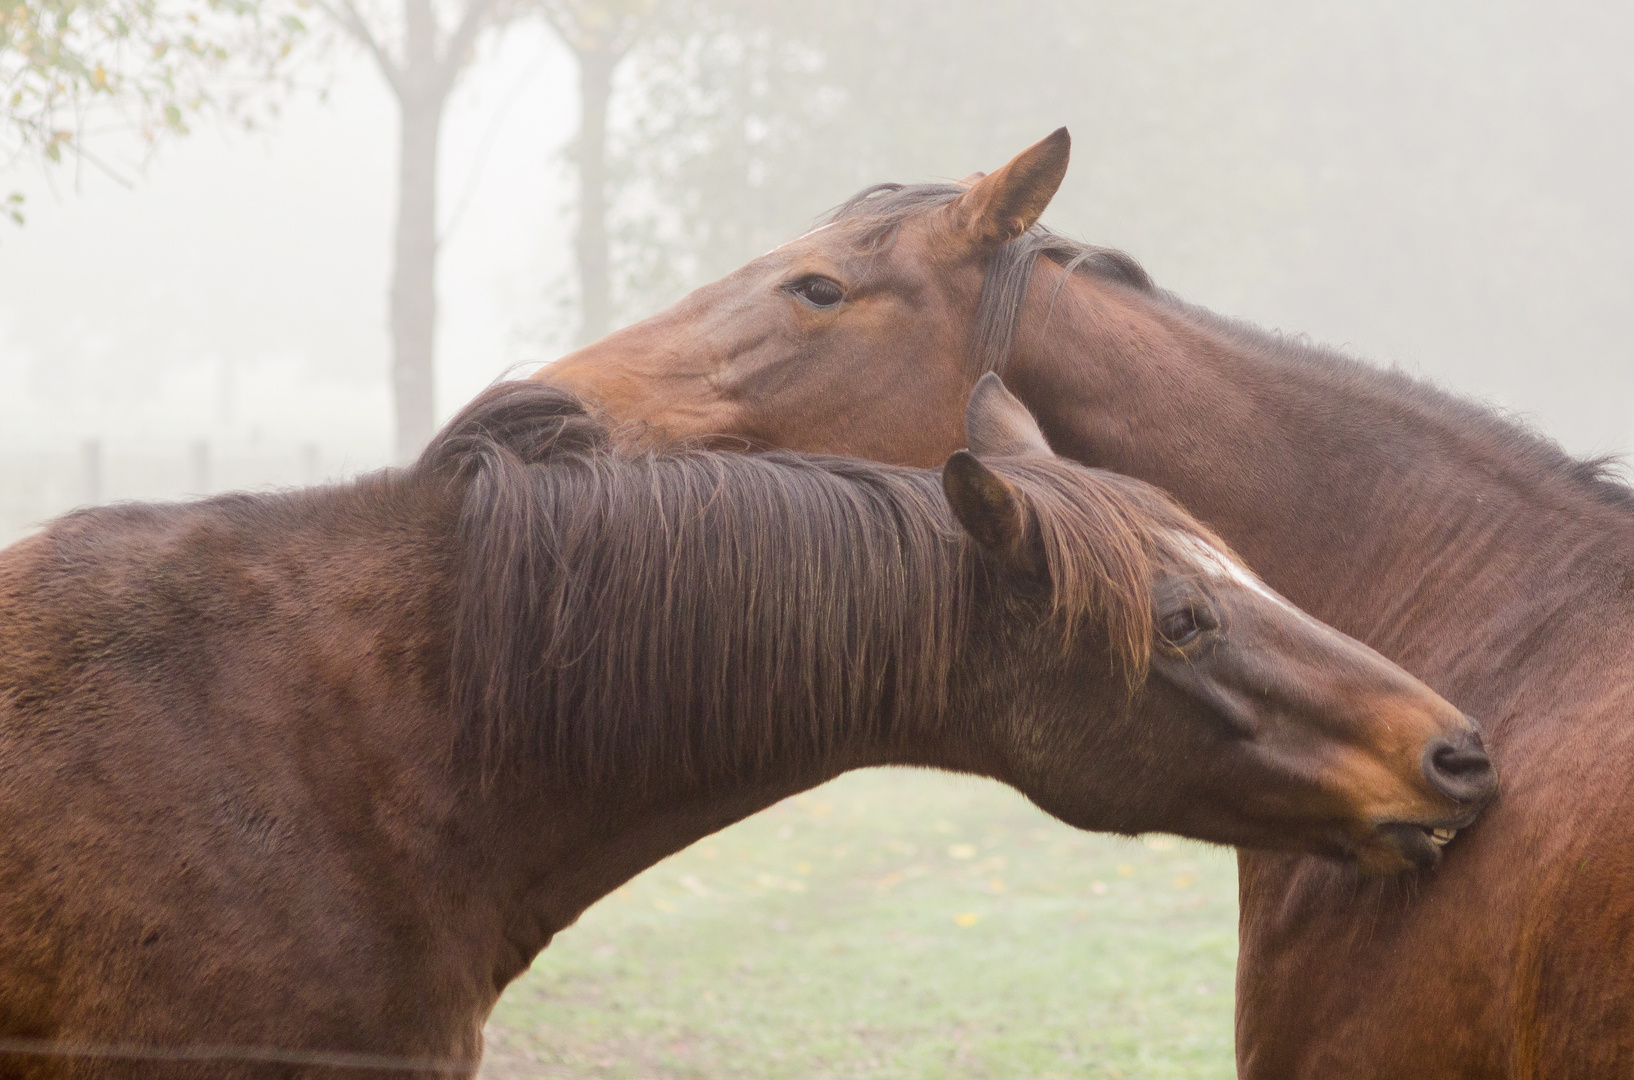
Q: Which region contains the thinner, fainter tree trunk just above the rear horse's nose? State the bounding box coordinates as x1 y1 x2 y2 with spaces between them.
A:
578 49 621 345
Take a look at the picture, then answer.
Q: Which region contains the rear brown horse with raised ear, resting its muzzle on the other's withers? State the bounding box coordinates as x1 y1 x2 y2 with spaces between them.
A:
541 129 1634 1080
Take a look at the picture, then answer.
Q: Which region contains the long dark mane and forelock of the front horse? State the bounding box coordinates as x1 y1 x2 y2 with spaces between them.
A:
415 381 1194 788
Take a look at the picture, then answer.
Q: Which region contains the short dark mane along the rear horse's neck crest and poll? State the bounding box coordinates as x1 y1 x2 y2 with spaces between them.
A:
825 183 1634 513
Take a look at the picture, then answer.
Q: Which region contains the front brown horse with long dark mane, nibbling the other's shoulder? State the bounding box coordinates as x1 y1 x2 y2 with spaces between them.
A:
0 379 1495 1077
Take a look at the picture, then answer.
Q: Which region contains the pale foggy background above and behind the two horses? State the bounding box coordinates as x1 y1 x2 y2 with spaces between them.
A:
0 0 1634 542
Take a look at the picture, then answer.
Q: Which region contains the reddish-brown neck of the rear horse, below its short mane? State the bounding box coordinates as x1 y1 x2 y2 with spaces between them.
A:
1005 265 1634 712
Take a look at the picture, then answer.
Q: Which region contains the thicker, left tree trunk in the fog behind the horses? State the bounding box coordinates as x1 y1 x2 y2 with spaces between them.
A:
391 87 444 464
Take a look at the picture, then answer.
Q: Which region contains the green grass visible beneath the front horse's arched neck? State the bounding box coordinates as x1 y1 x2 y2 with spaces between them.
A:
484 770 1237 1080
